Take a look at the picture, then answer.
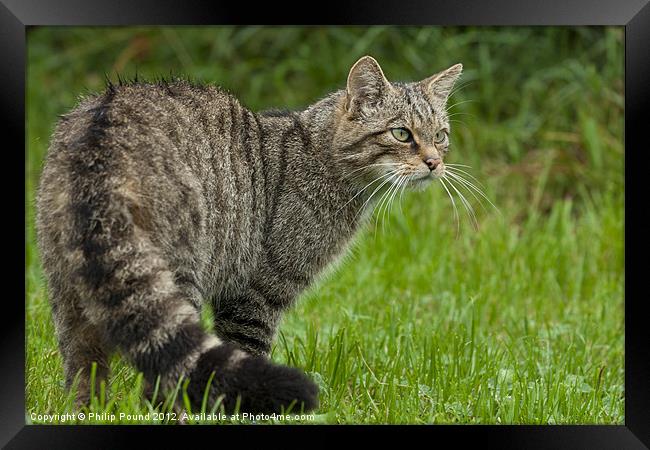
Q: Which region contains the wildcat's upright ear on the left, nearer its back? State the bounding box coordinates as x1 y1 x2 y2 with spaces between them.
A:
345 56 392 113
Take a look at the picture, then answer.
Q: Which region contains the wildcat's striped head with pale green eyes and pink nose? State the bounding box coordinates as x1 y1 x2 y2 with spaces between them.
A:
333 56 463 191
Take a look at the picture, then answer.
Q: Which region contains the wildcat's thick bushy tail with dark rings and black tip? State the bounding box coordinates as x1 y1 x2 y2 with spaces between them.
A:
66 184 318 413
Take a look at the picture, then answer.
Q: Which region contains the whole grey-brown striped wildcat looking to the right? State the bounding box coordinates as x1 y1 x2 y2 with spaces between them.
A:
37 56 462 412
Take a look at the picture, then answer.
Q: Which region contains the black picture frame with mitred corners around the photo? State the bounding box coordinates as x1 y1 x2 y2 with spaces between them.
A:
6 0 650 450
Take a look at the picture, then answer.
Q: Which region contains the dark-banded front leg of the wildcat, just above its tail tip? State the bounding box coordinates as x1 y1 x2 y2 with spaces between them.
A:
212 287 281 355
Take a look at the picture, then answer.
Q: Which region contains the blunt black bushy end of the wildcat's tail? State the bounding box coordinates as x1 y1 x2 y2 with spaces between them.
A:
188 344 318 414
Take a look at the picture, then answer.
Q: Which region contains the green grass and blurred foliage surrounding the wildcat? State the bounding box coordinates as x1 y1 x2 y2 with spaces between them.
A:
25 27 624 424
